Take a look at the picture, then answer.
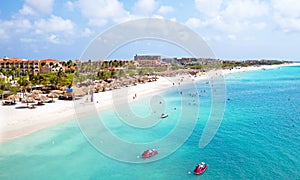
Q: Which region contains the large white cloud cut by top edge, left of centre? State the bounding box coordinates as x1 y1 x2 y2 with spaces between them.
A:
78 0 129 26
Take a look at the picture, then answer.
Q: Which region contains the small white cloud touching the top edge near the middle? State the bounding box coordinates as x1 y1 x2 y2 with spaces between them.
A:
133 0 158 16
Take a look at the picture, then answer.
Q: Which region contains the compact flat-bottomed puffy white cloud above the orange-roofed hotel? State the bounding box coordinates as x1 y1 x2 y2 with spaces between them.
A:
34 15 74 34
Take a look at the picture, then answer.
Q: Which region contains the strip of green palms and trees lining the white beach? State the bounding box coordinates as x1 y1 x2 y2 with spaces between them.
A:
0 59 286 98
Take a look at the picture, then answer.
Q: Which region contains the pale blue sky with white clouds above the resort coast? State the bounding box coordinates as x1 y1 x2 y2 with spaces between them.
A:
0 0 300 60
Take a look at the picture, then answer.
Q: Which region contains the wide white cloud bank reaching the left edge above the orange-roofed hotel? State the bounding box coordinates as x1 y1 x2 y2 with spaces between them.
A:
0 15 75 44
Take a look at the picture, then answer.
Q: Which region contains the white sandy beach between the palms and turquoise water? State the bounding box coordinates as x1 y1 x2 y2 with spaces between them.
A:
0 63 297 143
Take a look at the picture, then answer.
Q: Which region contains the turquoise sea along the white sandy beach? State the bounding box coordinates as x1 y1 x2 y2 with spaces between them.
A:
0 65 300 179
